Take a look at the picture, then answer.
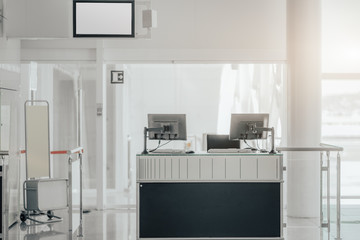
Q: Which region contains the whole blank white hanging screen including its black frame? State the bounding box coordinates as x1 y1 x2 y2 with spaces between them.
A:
73 0 135 37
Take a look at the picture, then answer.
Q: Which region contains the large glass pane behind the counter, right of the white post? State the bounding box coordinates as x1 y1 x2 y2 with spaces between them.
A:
106 64 286 207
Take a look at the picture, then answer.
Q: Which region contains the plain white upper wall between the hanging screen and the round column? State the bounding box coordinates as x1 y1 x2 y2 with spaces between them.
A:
105 0 286 61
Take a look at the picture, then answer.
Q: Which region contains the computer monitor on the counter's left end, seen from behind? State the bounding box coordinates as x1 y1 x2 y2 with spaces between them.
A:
148 114 186 140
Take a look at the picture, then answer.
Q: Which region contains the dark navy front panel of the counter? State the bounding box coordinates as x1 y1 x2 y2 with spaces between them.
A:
139 182 281 238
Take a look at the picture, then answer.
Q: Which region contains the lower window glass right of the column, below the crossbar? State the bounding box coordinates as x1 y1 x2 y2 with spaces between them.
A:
322 78 360 239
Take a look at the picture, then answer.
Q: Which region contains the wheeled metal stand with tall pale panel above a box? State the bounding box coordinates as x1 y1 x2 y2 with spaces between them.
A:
20 100 64 224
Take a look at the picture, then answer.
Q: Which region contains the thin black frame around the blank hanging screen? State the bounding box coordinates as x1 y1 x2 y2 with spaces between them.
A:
73 0 135 38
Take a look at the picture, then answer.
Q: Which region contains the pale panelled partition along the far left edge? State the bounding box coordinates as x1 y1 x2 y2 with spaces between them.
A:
0 63 22 239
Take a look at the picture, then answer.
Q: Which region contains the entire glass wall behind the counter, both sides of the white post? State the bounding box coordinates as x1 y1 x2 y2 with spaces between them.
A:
18 63 286 208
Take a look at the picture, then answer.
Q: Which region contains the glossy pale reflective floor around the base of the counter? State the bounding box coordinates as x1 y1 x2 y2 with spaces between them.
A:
8 205 360 240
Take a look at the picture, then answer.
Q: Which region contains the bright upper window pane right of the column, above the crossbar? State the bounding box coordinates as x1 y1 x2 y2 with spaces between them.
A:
322 0 360 73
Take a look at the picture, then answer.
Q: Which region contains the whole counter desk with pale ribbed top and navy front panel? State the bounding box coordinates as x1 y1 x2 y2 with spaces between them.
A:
137 153 283 239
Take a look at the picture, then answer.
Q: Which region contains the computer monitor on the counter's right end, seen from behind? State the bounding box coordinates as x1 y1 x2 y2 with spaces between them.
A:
230 113 269 140
